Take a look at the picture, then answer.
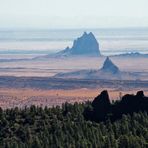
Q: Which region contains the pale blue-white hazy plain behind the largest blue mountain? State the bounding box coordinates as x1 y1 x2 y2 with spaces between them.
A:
0 28 148 58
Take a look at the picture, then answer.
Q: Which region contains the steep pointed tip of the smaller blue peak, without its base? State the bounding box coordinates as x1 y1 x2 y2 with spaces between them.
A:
101 57 120 73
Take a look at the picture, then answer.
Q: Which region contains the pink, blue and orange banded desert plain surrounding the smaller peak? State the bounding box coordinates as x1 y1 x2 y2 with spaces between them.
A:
0 56 148 108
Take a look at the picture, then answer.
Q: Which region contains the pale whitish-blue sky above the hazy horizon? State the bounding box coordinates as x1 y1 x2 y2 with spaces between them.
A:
0 0 148 29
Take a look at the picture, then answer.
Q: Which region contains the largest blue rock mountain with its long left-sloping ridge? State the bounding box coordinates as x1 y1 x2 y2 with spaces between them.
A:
35 32 101 59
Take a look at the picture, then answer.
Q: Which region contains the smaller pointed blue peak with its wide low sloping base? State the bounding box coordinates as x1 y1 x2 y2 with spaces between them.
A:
55 57 138 80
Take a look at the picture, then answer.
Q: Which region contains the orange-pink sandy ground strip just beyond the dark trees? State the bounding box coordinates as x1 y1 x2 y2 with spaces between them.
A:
0 88 148 109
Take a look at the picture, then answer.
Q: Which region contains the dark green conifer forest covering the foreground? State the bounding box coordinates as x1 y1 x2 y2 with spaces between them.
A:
0 91 148 148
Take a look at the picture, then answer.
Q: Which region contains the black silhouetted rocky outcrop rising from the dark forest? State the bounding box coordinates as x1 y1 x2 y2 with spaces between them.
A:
84 91 148 122
